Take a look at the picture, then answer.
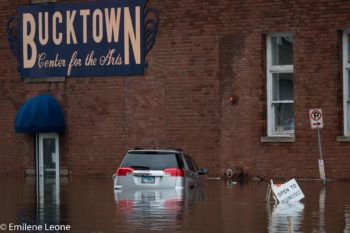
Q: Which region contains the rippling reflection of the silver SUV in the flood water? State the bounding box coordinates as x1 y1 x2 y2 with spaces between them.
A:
114 188 205 231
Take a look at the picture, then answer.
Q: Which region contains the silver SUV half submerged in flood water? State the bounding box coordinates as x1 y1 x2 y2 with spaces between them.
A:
114 149 208 189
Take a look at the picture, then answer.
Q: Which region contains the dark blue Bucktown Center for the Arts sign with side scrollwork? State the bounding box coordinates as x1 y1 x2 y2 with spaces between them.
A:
8 0 159 78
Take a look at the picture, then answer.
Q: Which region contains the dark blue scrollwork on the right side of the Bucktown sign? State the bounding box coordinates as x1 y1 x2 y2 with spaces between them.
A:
144 7 159 60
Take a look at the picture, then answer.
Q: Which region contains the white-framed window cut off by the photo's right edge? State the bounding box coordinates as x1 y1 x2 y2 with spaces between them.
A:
343 29 350 136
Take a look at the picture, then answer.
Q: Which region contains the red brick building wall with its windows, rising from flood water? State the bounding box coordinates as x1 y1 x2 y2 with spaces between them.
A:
0 0 350 179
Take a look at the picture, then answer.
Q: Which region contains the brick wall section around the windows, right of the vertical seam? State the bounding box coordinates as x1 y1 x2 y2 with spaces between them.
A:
219 1 350 178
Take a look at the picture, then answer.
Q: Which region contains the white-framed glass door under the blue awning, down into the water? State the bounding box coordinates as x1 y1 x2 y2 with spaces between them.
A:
36 133 60 205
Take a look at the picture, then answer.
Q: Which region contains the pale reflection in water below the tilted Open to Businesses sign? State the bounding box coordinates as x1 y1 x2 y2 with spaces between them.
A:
267 202 304 233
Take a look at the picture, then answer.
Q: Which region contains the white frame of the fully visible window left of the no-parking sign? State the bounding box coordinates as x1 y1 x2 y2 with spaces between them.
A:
266 33 295 137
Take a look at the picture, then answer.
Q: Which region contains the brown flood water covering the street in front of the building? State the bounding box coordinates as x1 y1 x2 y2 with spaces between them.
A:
0 177 350 233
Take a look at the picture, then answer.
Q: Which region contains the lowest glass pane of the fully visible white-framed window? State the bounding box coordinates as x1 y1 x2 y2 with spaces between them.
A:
274 103 294 132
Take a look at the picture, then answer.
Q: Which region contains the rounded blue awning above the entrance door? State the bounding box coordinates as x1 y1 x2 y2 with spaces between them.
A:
15 95 64 133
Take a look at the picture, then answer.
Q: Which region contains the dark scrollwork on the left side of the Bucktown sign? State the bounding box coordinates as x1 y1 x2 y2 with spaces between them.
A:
7 16 19 62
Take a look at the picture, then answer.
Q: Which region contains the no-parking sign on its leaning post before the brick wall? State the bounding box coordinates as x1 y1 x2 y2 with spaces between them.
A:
309 109 326 184
